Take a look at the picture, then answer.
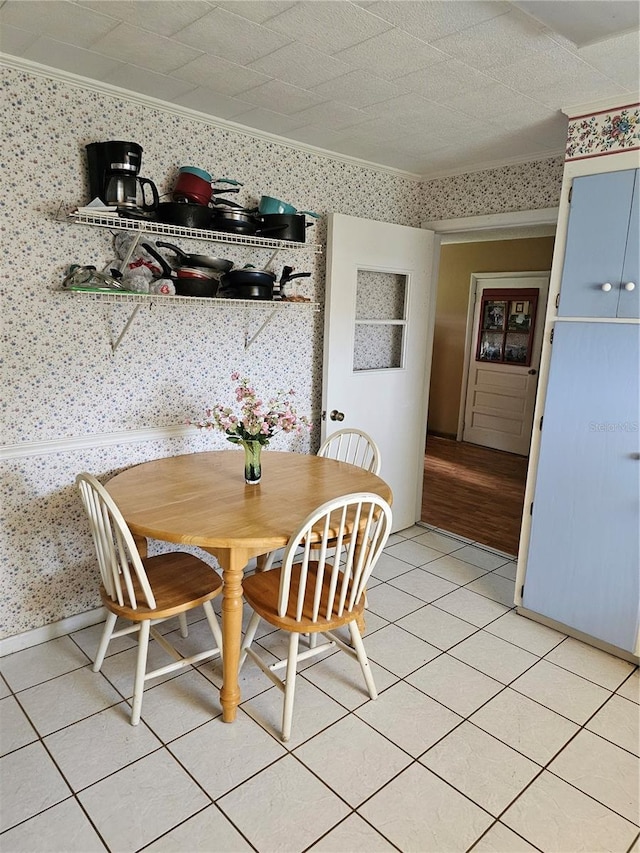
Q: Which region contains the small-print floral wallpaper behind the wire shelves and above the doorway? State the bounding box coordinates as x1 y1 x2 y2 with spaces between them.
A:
0 68 561 637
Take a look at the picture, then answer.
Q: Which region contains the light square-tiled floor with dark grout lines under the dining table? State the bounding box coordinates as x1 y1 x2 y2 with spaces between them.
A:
0 525 640 853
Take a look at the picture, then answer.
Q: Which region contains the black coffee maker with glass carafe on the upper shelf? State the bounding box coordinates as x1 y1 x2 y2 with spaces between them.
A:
85 140 159 218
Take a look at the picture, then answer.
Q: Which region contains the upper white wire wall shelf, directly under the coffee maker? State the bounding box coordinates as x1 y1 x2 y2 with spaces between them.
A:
67 213 322 255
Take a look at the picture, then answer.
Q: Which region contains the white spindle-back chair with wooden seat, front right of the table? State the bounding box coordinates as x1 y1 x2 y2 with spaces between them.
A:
240 492 391 741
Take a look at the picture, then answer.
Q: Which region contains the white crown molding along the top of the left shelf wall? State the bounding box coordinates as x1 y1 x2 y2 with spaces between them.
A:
0 53 430 183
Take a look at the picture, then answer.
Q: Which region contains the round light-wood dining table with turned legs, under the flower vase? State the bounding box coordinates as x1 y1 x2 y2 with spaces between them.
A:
106 450 392 722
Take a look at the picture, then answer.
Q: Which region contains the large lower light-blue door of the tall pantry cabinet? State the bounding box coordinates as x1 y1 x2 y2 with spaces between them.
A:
523 322 640 651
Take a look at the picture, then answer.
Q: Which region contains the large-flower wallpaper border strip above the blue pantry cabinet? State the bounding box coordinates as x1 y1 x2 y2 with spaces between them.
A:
566 104 640 160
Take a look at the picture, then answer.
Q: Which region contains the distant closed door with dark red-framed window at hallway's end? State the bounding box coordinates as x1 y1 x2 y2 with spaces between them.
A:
462 272 549 456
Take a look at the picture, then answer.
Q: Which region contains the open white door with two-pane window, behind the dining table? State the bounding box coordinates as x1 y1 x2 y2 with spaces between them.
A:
322 213 437 530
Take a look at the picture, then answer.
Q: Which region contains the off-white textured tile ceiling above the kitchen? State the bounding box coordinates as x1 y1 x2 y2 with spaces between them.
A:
0 0 640 176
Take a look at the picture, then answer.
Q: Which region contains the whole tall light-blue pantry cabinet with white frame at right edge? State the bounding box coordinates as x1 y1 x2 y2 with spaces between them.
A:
516 131 640 659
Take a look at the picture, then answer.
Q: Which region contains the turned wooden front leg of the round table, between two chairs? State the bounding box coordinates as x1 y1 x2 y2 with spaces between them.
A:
211 548 252 723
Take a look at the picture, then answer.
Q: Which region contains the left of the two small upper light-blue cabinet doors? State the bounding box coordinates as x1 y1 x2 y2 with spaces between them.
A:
558 169 638 317
